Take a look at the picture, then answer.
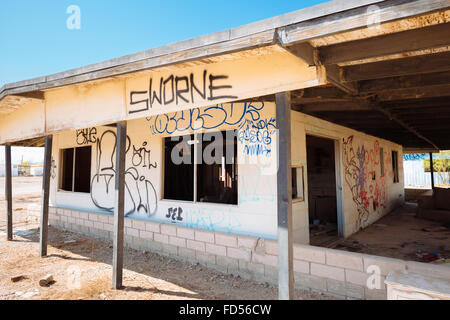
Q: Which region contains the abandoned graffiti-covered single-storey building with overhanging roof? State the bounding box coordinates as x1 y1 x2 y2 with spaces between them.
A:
0 0 450 299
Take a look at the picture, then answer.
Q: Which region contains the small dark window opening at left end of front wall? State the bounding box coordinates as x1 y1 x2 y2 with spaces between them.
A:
60 146 92 193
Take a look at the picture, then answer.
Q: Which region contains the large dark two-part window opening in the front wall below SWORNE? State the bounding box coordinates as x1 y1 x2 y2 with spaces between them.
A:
164 131 238 204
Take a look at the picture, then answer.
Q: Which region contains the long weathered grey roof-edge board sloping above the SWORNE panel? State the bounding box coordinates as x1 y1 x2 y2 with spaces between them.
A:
0 0 382 99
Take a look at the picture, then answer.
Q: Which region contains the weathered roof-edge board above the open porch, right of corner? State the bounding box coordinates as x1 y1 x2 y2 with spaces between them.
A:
280 0 450 45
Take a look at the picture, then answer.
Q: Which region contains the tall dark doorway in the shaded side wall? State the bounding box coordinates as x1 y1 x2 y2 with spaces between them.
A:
306 135 340 247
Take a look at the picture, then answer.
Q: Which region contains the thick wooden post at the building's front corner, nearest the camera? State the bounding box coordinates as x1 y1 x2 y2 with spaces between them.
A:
276 92 294 300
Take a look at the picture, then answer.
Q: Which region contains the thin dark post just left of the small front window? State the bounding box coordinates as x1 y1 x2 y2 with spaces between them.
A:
39 135 53 258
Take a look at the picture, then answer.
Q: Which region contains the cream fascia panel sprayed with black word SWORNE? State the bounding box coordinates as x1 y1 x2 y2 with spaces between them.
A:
126 51 325 119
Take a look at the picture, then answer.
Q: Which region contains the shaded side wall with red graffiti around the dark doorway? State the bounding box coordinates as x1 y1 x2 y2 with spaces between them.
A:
292 111 404 244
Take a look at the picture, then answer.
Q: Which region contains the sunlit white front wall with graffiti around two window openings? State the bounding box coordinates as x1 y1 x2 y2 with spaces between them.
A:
51 103 277 238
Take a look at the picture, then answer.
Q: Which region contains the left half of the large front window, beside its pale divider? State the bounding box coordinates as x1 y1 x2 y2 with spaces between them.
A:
164 135 194 201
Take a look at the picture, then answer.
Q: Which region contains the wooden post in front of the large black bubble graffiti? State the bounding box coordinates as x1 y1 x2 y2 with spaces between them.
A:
113 121 127 289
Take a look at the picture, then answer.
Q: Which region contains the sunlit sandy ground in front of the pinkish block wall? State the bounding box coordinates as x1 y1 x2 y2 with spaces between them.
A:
0 179 335 300
